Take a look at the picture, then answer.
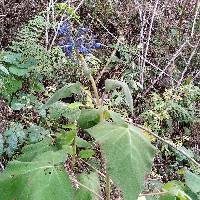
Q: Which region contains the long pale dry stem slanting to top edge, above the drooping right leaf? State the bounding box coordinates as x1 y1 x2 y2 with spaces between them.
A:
141 0 159 87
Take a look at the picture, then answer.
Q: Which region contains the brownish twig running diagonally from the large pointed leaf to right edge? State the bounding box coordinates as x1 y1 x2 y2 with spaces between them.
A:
133 123 200 168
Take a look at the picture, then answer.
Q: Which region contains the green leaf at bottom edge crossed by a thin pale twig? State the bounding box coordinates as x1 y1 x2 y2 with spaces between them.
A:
75 173 100 200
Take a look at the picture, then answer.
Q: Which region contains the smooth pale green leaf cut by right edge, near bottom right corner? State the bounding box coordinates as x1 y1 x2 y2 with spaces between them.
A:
185 171 200 193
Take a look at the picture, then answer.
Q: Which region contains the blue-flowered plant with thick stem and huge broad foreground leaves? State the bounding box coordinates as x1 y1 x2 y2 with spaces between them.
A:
0 1 200 200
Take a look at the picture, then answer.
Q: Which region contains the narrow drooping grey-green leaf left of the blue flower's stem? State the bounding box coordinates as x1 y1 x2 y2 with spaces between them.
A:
45 82 81 107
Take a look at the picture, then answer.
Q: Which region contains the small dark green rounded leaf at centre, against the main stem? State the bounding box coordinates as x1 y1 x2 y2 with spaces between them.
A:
77 109 100 129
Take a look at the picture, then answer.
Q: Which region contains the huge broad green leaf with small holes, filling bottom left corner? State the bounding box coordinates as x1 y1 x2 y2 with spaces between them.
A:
0 140 73 200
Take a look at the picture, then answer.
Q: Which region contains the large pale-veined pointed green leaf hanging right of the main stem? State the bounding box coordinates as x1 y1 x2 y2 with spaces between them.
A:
87 123 155 200
